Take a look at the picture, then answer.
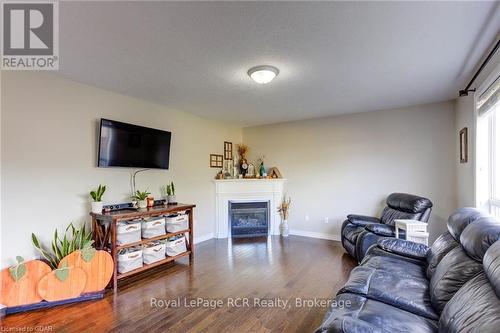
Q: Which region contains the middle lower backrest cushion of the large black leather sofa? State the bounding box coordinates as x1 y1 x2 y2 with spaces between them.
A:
430 246 483 312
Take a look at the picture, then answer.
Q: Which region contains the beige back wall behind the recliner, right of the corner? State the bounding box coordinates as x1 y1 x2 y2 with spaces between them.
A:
243 102 456 240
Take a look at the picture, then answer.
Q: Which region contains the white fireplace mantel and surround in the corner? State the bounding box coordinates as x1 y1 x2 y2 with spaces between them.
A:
214 178 286 238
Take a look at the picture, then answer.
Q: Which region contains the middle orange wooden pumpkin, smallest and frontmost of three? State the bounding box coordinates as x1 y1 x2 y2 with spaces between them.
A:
37 260 87 302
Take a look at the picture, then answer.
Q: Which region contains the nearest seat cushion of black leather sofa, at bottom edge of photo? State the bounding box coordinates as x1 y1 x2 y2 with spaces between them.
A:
317 293 437 333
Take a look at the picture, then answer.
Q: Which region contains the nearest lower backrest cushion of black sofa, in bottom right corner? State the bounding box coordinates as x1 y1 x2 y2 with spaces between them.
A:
439 272 500 333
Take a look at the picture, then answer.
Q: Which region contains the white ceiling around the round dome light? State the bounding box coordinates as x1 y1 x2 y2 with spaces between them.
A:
59 1 500 126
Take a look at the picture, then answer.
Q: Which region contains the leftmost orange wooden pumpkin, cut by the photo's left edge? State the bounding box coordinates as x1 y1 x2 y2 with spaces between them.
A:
0 257 51 307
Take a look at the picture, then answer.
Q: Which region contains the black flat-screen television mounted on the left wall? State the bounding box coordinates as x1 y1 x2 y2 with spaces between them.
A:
97 119 172 169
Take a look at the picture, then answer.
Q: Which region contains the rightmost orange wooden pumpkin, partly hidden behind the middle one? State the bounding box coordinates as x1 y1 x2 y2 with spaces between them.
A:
58 248 114 293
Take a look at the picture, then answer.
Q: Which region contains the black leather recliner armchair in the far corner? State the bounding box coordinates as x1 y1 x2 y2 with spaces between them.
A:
341 193 432 262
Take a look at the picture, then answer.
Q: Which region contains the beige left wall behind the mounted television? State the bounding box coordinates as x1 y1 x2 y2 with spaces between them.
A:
0 71 241 267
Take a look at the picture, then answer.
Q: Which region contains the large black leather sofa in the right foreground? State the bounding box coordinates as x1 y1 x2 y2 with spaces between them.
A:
317 208 500 333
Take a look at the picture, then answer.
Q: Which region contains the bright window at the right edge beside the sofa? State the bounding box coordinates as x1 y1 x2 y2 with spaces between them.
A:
477 78 500 217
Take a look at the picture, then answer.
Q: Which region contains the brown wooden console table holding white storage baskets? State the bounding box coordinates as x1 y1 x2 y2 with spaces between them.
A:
90 204 196 292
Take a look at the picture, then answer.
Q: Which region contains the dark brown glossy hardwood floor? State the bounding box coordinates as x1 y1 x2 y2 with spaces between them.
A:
2 236 356 333
